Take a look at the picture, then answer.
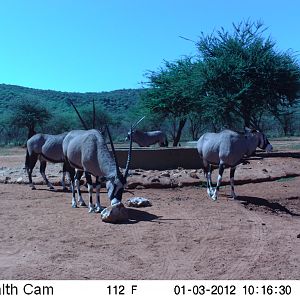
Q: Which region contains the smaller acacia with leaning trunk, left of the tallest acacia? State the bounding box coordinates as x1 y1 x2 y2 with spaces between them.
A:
142 58 200 146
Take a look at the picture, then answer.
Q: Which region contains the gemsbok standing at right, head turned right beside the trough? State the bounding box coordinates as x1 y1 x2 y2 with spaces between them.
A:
197 128 273 200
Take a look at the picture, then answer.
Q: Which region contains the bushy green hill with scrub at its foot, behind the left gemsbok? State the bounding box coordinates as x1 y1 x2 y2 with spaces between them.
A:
0 84 142 144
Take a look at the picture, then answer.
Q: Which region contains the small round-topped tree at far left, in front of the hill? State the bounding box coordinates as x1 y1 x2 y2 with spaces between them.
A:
10 100 51 138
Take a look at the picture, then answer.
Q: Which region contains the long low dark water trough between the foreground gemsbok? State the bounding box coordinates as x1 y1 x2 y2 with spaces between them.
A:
116 147 201 170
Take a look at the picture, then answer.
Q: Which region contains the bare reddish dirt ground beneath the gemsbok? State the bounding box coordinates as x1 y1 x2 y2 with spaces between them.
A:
0 143 300 279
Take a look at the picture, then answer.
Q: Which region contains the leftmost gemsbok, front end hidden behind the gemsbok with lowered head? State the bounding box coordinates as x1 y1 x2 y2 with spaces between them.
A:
25 132 67 190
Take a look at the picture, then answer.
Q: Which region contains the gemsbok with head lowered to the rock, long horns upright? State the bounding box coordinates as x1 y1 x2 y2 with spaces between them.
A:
63 127 132 212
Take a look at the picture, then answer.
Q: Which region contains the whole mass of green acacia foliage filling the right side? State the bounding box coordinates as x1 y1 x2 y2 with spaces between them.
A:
143 21 300 143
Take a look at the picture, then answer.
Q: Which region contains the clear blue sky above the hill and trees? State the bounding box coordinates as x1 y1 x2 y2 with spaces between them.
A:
0 0 300 92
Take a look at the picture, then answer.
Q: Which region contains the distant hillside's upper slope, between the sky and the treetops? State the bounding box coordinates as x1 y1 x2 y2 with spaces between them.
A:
0 84 142 115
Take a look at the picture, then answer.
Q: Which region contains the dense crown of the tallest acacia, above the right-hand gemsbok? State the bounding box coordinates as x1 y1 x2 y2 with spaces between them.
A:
197 21 300 127
